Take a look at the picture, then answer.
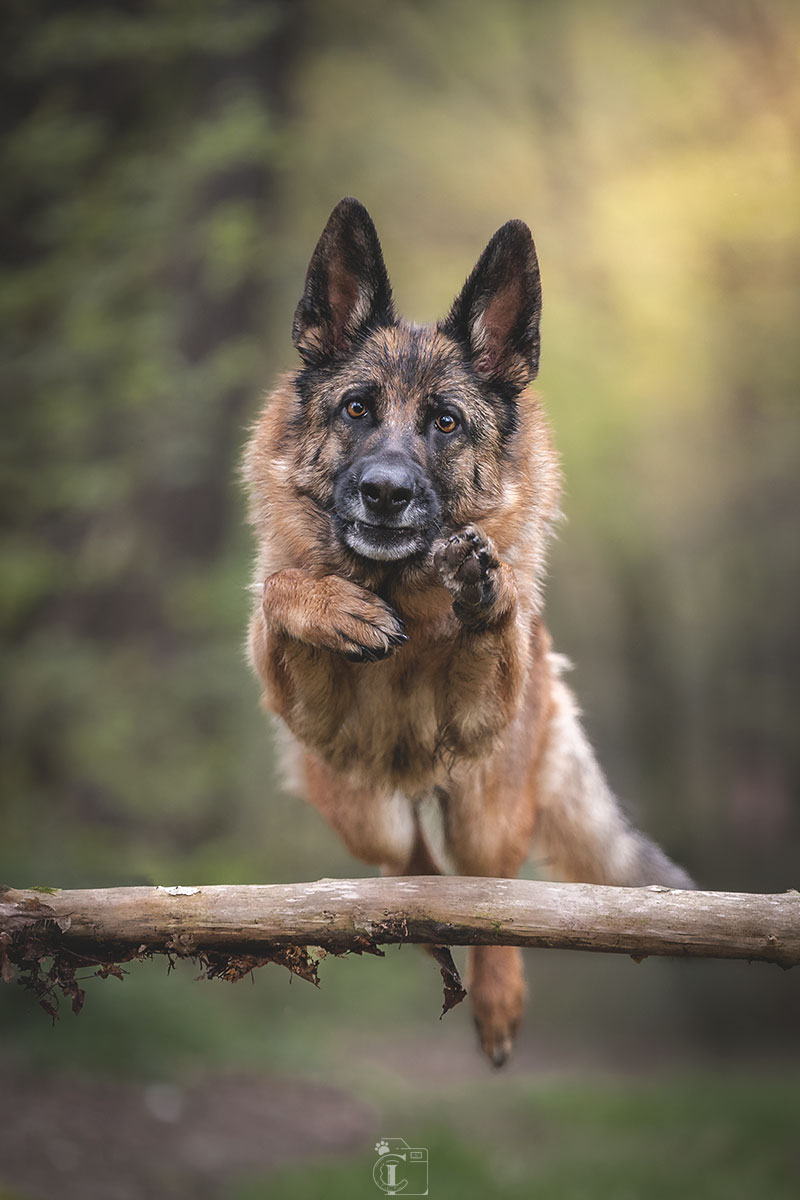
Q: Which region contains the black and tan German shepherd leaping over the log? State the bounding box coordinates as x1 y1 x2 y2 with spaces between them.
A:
245 199 692 1066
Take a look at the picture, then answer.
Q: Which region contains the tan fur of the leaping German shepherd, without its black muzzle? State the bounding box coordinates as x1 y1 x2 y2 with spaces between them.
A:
245 208 688 1063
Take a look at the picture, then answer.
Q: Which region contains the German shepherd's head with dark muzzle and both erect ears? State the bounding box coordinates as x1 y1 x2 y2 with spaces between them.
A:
293 199 541 564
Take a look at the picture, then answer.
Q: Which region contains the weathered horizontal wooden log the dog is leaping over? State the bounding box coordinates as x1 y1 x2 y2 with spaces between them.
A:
0 876 800 967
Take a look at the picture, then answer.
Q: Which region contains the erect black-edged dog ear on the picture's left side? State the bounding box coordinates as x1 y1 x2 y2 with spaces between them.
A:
291 197 396 364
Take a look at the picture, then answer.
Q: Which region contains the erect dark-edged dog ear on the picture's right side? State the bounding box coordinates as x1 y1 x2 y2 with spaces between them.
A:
439 221 542 391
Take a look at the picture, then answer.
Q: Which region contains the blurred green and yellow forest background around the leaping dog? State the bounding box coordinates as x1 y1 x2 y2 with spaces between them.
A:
0 0 800 1200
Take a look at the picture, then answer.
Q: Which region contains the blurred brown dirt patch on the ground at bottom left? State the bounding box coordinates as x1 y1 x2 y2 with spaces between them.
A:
0 1069 377 1200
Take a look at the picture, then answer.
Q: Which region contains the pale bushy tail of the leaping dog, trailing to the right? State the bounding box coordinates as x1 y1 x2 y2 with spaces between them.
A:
534 654 694 888
